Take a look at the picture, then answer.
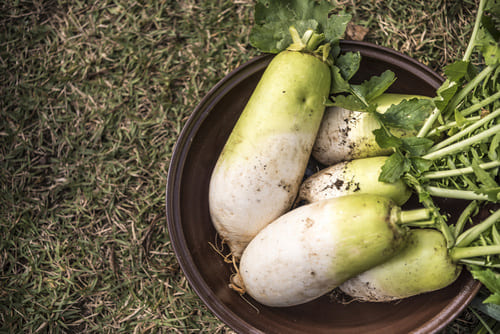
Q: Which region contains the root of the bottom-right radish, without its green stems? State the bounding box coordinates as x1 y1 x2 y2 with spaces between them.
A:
340 229 462 302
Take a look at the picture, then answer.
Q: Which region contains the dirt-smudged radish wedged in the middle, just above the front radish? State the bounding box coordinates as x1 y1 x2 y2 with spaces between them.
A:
296 156 412 206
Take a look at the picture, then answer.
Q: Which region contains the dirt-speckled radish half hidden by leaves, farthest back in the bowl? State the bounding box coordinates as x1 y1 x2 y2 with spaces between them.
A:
312 93 428 166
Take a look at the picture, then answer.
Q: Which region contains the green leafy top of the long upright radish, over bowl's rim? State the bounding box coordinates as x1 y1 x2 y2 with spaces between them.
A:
250 0 351 53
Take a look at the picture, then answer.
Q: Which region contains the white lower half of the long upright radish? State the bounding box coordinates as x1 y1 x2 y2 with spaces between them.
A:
211 134 308 253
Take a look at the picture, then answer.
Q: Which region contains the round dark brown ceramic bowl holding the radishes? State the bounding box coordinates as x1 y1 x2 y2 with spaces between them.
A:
166 41 480 334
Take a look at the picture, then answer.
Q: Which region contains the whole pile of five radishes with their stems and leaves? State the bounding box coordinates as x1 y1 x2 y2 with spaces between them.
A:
205 0 500 316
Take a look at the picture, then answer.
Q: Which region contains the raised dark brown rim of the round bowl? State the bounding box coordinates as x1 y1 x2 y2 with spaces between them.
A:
165 40 481 334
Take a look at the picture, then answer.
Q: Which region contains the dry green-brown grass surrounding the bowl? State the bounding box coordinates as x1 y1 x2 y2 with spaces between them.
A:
0 0 492 333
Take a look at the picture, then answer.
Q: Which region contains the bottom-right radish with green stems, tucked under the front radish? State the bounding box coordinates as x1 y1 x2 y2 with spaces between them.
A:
340 210 500 302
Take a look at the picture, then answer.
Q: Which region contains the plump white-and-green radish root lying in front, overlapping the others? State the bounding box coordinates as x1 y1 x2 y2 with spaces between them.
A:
235 194 407 307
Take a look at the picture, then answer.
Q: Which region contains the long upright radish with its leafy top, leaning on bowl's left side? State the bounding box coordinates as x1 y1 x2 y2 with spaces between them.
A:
209 0 350 259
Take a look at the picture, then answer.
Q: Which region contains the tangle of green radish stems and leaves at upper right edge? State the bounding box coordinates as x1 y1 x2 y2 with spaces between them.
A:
376 0 500 188
